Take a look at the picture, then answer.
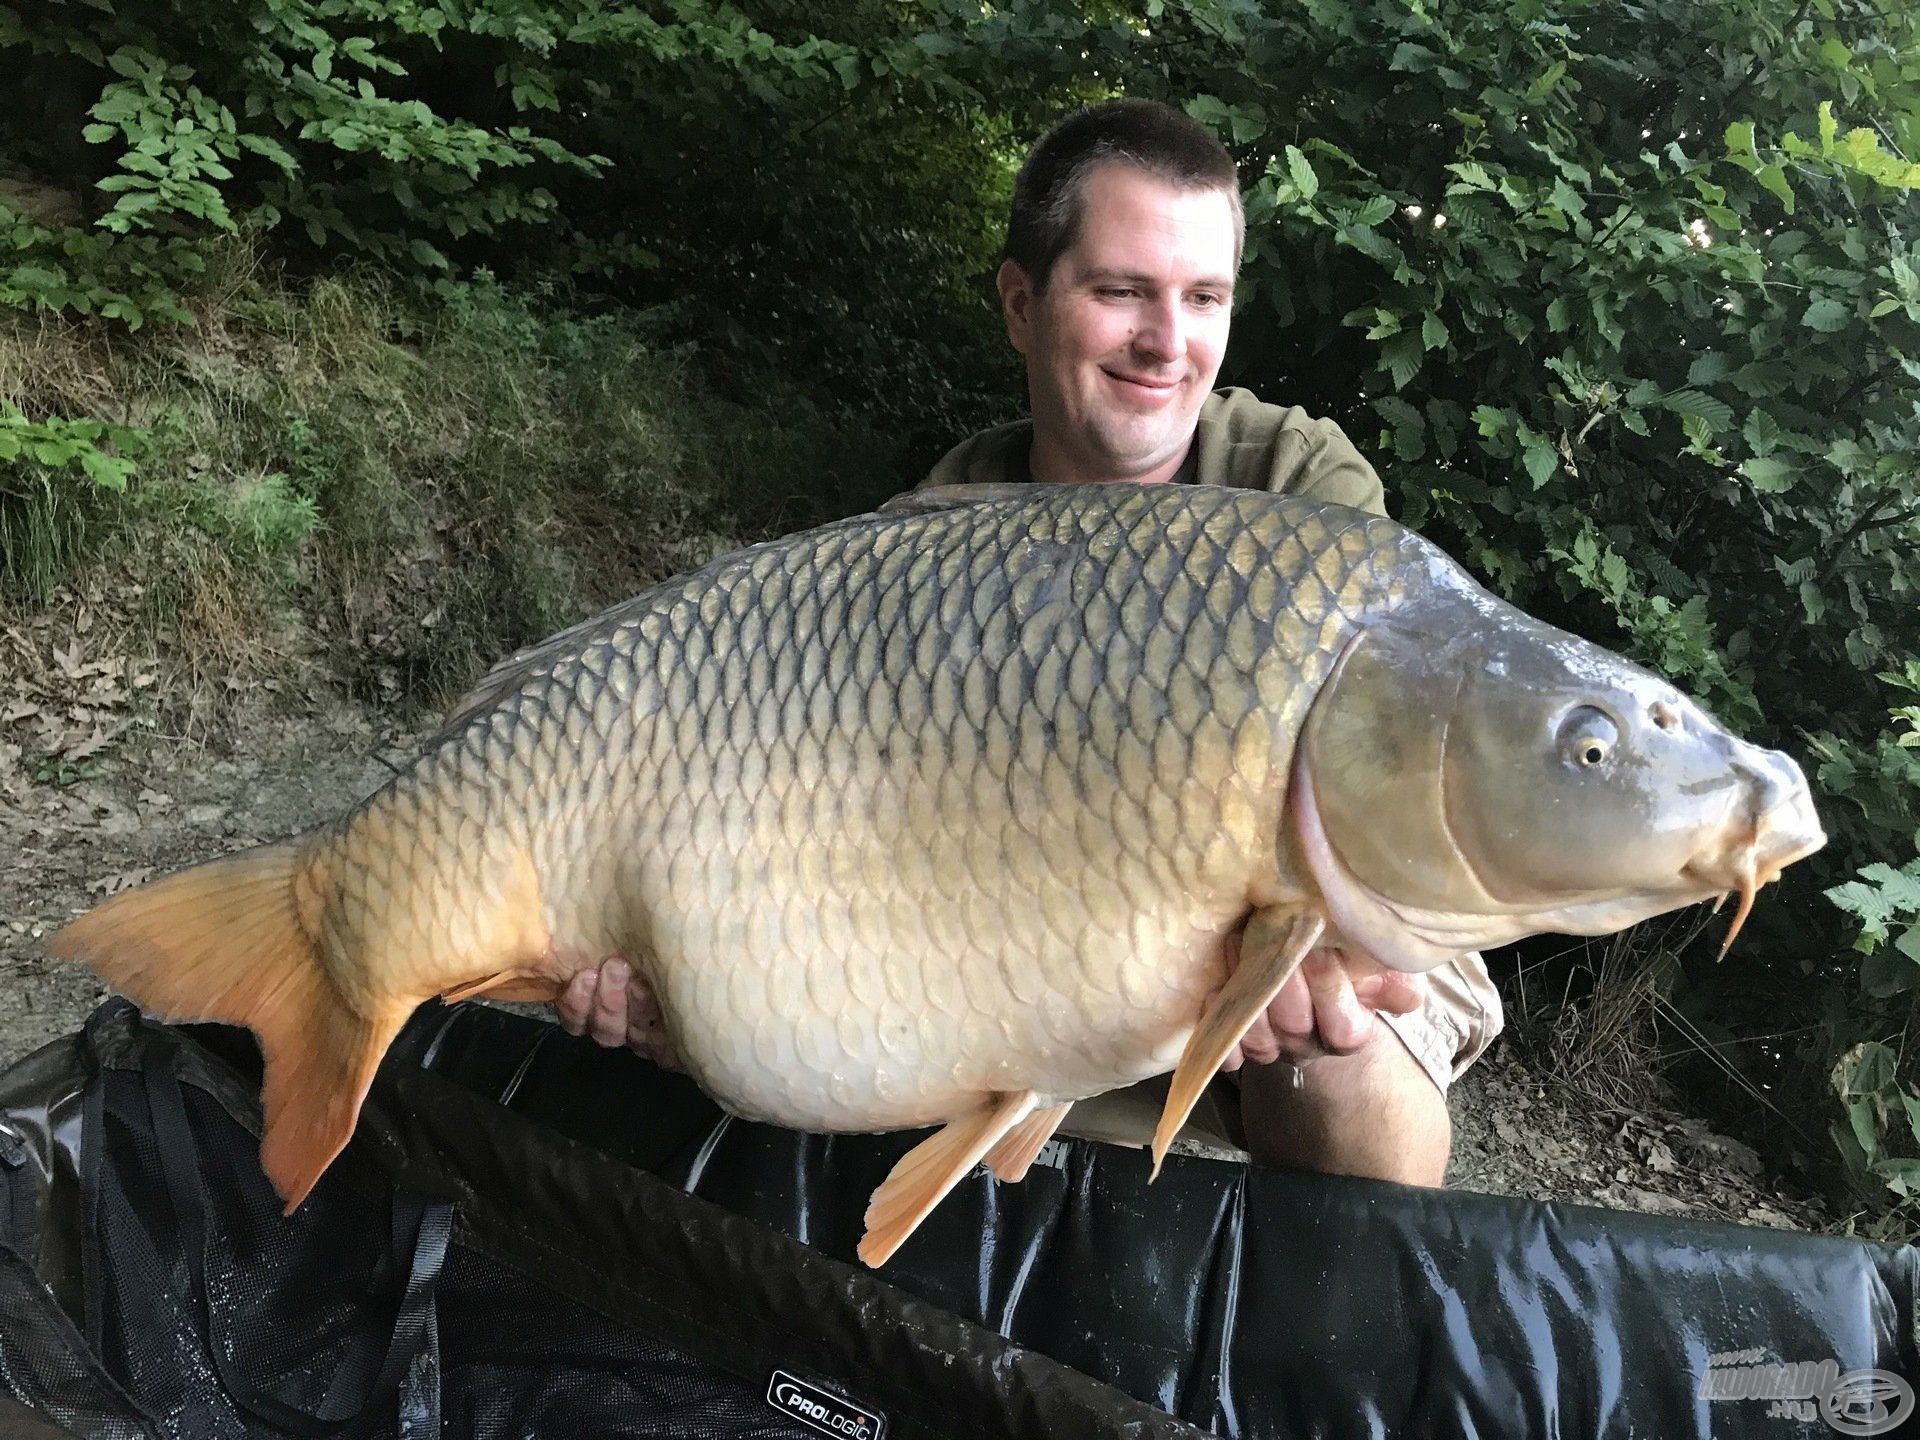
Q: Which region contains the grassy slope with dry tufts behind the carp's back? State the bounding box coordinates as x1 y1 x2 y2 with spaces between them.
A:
0 263 906 707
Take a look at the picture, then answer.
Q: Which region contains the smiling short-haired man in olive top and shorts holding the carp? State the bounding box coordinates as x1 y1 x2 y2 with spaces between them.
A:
559 100 1500 1185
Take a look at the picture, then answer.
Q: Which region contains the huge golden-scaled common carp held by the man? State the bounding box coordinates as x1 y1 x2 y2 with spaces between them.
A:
54 484 1824 1263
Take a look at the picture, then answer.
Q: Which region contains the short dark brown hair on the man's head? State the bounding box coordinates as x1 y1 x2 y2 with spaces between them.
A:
1006 100 1246 290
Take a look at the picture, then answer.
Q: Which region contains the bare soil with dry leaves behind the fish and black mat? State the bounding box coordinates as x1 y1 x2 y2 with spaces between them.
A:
0 597 1837 1229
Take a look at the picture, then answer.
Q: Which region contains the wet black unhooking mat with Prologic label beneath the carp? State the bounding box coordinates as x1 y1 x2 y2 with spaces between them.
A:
0 1000 1920 1440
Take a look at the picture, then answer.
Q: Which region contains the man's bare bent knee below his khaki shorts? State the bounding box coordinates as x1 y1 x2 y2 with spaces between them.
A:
1240 1027 1453 1185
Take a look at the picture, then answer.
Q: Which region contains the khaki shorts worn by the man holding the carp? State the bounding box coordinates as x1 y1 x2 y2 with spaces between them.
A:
1060 954 1505 1160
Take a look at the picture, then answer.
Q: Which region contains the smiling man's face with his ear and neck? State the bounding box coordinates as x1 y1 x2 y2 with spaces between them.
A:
1000 163 1235 480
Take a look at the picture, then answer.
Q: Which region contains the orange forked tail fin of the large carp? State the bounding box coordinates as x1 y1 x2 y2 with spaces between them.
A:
50 841 413 1213
